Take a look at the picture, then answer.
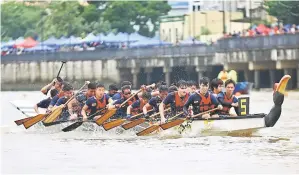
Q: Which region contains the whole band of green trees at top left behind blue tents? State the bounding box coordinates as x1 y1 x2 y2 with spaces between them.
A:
1 1 170 40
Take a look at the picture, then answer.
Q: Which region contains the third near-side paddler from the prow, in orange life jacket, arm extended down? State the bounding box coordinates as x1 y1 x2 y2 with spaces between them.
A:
159 80 189 123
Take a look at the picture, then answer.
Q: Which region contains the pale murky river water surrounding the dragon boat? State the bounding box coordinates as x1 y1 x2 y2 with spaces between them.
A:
1 92 299 174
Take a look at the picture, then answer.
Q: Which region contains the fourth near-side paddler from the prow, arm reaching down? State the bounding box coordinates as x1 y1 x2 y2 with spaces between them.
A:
143 85 168 117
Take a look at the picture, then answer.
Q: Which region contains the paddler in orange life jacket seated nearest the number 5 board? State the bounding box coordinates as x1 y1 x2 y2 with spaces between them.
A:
217 79 238 117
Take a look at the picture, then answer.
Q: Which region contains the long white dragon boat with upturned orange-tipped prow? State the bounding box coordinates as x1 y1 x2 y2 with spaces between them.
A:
11 75 291 136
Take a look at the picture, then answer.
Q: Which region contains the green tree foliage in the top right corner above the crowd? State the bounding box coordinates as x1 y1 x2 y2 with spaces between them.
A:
265 1 299 24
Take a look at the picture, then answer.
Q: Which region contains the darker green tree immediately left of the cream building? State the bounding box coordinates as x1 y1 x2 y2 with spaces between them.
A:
103 1 171 37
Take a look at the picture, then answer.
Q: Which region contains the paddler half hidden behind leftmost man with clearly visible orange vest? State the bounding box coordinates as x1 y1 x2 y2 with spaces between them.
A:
68 83 97 120
